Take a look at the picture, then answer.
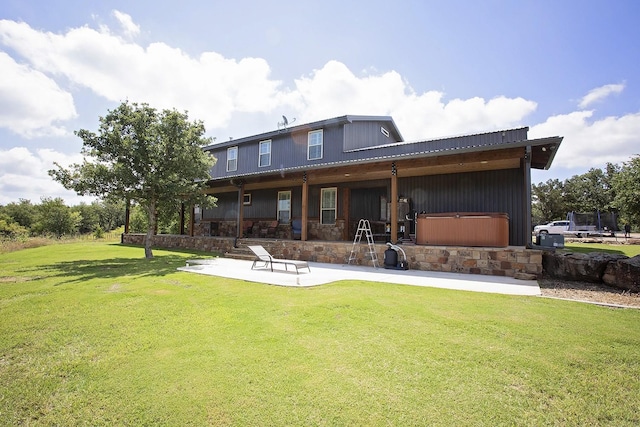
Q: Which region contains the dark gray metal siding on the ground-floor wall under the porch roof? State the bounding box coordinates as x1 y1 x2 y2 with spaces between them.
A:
204 169 526 246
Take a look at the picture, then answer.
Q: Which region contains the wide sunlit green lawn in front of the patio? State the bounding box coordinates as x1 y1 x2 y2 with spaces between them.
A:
0 242 640 426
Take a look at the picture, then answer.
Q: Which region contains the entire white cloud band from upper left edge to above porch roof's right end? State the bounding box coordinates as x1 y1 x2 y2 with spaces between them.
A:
0 17 536 139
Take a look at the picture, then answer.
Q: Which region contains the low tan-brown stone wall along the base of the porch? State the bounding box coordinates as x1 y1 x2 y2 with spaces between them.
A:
122 234 542 279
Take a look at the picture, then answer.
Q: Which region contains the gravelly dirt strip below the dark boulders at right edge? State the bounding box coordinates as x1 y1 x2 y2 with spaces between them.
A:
538 279 640 308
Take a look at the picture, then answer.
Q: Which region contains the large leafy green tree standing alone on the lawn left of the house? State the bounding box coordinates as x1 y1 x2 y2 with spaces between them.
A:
49 102 215 258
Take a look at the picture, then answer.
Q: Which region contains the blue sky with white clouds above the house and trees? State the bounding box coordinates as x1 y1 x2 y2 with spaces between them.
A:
0 0 640 204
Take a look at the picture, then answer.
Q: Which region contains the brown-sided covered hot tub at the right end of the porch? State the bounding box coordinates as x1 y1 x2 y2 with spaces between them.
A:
416 212 509 247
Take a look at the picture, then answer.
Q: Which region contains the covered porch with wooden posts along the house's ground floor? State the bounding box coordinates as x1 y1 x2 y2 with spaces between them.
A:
181 138 557 246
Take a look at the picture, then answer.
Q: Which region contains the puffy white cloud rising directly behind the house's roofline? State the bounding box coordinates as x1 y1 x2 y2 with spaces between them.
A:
287 61 537 140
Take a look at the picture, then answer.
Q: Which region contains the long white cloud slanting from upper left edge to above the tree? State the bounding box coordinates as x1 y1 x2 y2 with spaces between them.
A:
0 20 280 128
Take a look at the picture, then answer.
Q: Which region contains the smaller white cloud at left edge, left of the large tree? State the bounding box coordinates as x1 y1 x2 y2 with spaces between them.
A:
0 52 76 138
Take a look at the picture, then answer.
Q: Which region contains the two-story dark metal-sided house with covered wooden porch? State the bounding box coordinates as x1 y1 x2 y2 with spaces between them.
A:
195 116 562 246
